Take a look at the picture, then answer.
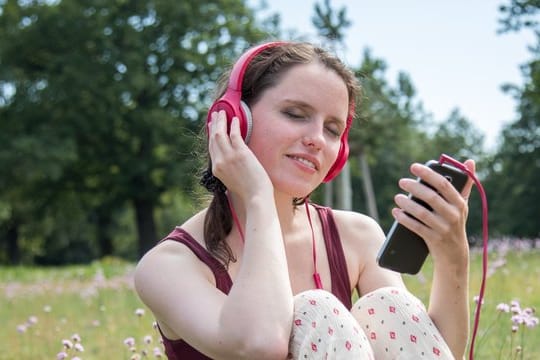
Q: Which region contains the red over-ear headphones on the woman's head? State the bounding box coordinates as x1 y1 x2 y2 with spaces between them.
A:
206 41 354 182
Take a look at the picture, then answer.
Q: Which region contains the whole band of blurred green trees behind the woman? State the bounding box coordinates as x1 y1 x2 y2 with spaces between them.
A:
0 0 540 264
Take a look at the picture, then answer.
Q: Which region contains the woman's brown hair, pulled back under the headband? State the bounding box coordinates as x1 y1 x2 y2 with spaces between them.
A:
200 42 360 267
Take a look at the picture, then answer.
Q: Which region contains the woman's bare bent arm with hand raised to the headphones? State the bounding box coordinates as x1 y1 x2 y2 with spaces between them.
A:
135 113 293 360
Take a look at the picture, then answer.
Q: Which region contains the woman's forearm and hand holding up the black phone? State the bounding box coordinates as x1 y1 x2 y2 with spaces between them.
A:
392 161 474 358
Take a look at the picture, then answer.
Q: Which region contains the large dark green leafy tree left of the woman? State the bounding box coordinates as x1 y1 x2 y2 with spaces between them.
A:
0 0 275 262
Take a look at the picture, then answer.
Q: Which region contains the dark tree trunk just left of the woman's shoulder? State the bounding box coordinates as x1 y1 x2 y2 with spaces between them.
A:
133 199 156 258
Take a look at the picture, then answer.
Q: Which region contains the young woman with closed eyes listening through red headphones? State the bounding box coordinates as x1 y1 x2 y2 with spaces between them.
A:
135 42 474 359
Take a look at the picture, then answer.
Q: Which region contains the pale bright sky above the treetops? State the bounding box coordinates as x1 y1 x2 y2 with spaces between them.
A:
250 0 534 150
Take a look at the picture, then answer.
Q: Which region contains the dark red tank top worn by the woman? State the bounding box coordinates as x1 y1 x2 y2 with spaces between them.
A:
160 204 352 360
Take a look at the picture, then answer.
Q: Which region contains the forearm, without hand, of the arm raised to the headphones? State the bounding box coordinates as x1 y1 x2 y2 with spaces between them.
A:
220 194 293 354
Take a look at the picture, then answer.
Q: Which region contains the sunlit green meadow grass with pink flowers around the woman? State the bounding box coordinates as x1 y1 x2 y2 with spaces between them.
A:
0 243 540 360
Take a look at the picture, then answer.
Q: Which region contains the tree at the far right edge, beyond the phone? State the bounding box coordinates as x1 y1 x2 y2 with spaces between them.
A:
487 0 540 238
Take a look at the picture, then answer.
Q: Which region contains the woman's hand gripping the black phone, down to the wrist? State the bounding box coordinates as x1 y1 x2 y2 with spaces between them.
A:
392 160 475 265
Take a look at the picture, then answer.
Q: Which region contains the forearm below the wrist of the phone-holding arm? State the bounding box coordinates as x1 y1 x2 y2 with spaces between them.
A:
428 257 469 359
